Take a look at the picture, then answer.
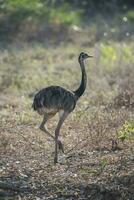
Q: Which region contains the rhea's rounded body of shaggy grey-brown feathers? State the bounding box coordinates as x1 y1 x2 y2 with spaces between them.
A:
33 86 76 115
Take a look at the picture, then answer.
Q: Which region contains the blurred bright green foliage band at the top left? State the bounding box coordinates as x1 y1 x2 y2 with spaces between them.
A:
0 0 81 25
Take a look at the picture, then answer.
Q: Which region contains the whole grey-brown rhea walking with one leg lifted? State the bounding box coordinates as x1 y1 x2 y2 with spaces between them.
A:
32 52 92 164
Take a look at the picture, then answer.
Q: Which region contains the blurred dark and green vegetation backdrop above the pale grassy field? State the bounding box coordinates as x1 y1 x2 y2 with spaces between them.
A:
0 0 134 43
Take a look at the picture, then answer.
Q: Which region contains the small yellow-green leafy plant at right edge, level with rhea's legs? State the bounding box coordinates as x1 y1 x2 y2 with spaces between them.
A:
118 121 134 141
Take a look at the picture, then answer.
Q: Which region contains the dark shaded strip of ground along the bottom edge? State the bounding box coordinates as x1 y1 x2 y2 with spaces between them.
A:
0 168 134 200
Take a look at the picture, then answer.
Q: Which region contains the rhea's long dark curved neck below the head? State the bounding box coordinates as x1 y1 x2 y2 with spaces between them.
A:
74 60 87 99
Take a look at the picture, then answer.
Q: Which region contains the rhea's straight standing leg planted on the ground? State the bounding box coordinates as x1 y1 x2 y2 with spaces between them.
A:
54 112 68 164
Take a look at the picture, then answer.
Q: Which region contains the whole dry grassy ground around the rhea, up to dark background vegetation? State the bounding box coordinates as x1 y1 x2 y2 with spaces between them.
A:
0 42 134 200
